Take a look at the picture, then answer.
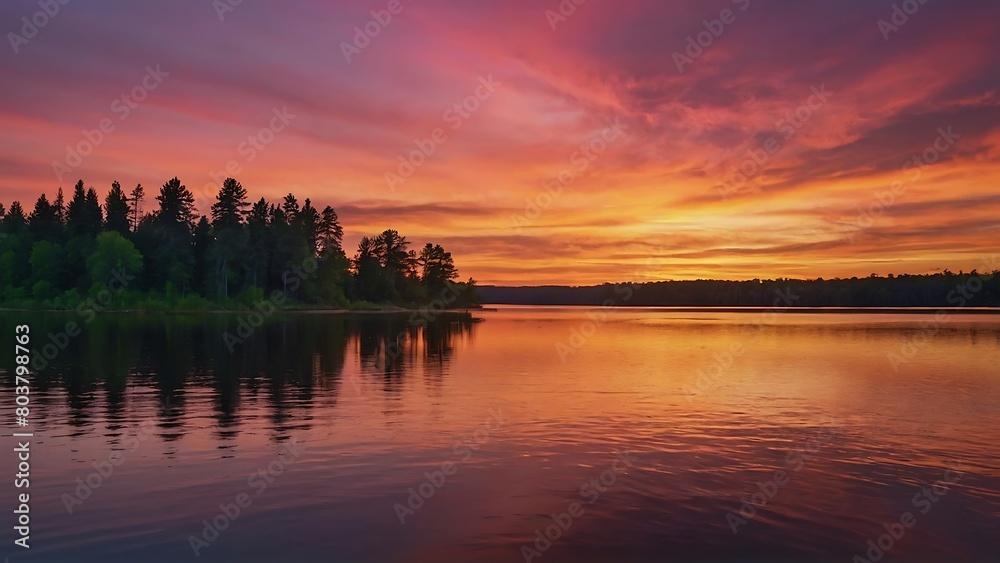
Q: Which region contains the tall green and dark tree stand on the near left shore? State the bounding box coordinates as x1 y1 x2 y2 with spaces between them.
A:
0 178 478 309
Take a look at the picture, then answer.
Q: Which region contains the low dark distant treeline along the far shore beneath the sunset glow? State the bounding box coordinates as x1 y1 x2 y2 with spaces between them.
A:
479 270 1000 307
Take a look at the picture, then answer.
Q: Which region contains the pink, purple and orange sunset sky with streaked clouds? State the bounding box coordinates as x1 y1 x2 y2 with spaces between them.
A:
0 0 1000 285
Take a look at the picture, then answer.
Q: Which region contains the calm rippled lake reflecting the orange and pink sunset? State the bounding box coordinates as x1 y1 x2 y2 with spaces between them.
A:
0 307 1000 563
